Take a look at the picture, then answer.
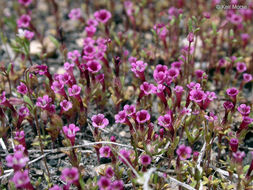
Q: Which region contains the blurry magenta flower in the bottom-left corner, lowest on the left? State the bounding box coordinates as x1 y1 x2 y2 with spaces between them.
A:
11 170 33 189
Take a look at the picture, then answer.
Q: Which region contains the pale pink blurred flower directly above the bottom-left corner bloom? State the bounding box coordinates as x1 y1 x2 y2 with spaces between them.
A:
6 151 29 171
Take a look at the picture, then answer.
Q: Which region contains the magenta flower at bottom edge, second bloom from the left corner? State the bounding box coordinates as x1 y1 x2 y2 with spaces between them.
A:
60 167 79 184
